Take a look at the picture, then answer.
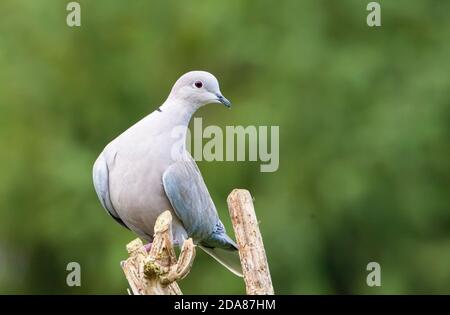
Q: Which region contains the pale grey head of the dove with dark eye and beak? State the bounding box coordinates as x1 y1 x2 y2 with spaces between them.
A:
169 71 231 108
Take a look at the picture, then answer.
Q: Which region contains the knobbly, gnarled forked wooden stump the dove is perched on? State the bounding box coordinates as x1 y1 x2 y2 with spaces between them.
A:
121 211 195 295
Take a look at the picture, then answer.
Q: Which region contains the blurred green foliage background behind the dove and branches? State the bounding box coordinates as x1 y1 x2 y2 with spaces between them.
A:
0 0 450 294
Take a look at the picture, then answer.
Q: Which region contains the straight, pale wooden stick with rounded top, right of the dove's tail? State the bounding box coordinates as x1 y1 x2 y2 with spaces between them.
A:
227 189 274 295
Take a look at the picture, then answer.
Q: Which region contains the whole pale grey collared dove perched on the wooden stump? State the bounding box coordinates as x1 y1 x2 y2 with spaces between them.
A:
93 71 242 276
